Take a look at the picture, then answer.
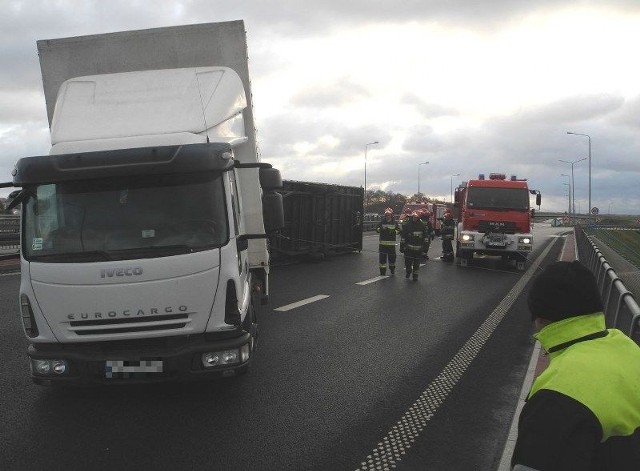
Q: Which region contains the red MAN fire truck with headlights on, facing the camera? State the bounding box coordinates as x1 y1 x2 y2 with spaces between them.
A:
455 173 542 270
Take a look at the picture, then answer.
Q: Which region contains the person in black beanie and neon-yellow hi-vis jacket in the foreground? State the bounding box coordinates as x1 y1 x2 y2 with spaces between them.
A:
511 261 640 471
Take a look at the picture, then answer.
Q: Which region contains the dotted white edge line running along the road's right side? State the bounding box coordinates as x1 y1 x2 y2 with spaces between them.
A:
358 236 554 471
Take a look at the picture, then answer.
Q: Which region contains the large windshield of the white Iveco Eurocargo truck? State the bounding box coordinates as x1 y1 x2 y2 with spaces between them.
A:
23 173 229 263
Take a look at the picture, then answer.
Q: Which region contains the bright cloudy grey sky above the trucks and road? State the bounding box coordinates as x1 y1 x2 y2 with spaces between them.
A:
0 0 640 215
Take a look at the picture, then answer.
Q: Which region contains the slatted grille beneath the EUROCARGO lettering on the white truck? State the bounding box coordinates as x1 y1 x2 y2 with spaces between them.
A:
69 312 191 336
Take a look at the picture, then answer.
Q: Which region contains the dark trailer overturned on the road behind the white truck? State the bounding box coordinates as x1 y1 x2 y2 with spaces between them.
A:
270 180 364 262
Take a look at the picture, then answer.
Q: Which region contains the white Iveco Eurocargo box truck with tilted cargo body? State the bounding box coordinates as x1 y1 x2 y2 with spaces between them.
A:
2 21 283 384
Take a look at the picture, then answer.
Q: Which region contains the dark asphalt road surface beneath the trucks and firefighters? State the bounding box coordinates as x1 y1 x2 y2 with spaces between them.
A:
0 224 563 471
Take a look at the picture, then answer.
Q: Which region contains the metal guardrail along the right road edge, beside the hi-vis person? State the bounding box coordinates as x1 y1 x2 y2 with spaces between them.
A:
575 227 640 345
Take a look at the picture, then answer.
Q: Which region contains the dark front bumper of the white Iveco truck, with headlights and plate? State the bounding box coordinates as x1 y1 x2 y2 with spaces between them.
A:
28 331 254 386
